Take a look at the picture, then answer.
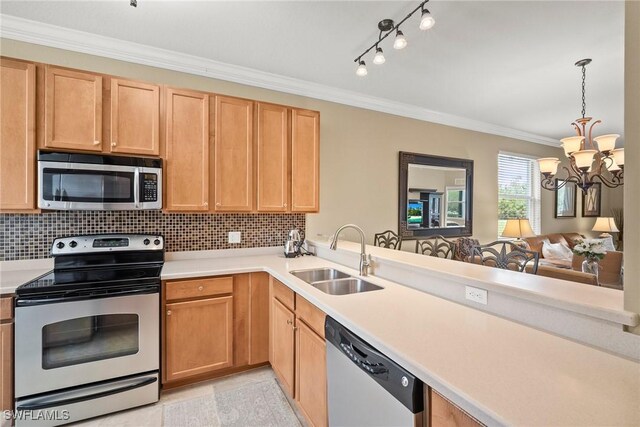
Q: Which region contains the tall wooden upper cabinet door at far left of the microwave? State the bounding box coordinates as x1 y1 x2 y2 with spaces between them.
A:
0 59 36 211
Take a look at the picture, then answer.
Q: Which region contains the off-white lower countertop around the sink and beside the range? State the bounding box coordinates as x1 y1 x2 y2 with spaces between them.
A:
5 249 640 426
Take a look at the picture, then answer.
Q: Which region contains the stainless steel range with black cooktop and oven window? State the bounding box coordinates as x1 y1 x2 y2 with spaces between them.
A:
15 234 164 426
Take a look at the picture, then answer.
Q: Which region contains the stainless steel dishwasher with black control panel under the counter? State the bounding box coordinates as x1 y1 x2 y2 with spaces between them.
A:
325 316 424 427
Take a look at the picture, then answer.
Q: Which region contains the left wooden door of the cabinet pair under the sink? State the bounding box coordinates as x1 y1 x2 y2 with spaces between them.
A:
271 298 295 397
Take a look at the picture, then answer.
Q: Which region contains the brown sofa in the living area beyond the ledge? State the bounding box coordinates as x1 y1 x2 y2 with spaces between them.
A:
523 233 622 289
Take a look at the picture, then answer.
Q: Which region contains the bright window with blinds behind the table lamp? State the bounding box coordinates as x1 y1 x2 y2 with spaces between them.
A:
498 153 540 236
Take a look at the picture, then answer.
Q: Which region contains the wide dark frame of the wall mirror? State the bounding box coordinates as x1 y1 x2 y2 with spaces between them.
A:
398 151 473 240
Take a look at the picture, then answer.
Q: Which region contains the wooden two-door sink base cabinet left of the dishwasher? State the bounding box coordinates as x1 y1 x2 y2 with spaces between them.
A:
270 278 328 426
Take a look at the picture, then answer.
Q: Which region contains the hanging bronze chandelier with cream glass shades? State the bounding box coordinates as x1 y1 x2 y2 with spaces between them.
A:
538 59 624 192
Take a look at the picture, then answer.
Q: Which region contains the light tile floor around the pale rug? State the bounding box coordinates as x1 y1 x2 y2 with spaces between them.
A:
73 367 307 427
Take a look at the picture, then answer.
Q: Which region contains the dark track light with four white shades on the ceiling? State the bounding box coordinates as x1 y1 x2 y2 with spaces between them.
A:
354 0 436 77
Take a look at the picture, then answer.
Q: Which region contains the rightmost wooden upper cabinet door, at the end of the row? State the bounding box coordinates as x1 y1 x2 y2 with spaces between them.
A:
291 109 320 212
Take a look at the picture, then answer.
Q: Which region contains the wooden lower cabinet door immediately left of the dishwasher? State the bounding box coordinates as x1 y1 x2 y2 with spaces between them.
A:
296 320 328 426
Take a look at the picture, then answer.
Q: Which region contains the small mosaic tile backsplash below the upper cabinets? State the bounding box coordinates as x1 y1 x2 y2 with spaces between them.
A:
0 211 305 261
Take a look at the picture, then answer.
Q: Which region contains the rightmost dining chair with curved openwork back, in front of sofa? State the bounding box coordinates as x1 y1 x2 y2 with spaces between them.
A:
472 240 540 274
